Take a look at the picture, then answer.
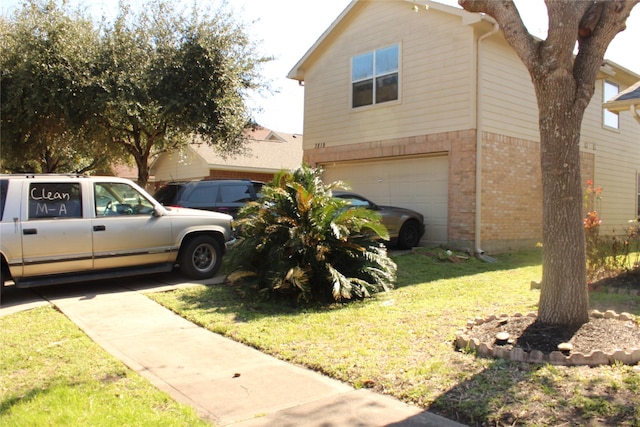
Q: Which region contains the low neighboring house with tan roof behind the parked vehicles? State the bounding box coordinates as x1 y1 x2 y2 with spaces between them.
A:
150 128 302 185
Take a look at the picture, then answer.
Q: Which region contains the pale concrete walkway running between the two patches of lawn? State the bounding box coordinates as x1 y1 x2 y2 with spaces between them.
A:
31 284 461 427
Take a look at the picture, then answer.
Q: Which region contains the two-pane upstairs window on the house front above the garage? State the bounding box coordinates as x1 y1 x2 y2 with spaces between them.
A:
351 45 399 108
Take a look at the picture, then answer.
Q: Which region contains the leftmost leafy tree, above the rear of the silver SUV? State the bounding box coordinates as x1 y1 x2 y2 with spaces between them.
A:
0 0 115 172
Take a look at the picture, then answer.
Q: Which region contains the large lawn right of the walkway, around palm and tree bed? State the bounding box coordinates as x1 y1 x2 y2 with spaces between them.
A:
151 250 640 426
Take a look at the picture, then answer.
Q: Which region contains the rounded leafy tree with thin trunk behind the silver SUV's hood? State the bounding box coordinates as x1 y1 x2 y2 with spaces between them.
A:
98 0 268 185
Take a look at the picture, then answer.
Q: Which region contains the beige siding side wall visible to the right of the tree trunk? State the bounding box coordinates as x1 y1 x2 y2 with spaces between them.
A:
581 78 640 233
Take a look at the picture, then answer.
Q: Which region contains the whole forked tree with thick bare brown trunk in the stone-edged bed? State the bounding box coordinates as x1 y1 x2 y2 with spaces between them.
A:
458 0 638 326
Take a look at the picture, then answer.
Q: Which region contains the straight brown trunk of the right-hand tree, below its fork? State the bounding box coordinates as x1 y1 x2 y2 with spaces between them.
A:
534 76 589 326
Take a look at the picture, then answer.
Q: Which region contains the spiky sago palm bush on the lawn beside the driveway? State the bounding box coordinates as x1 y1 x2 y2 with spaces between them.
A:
227 166 396 302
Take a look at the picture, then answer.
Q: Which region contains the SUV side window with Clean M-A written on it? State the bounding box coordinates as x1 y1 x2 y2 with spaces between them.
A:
29 182 82 219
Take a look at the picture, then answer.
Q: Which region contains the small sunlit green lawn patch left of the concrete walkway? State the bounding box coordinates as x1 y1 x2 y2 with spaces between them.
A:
0 307 210 427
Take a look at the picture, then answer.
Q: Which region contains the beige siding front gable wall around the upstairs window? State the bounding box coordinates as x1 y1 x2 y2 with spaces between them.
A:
304 1 475 149
